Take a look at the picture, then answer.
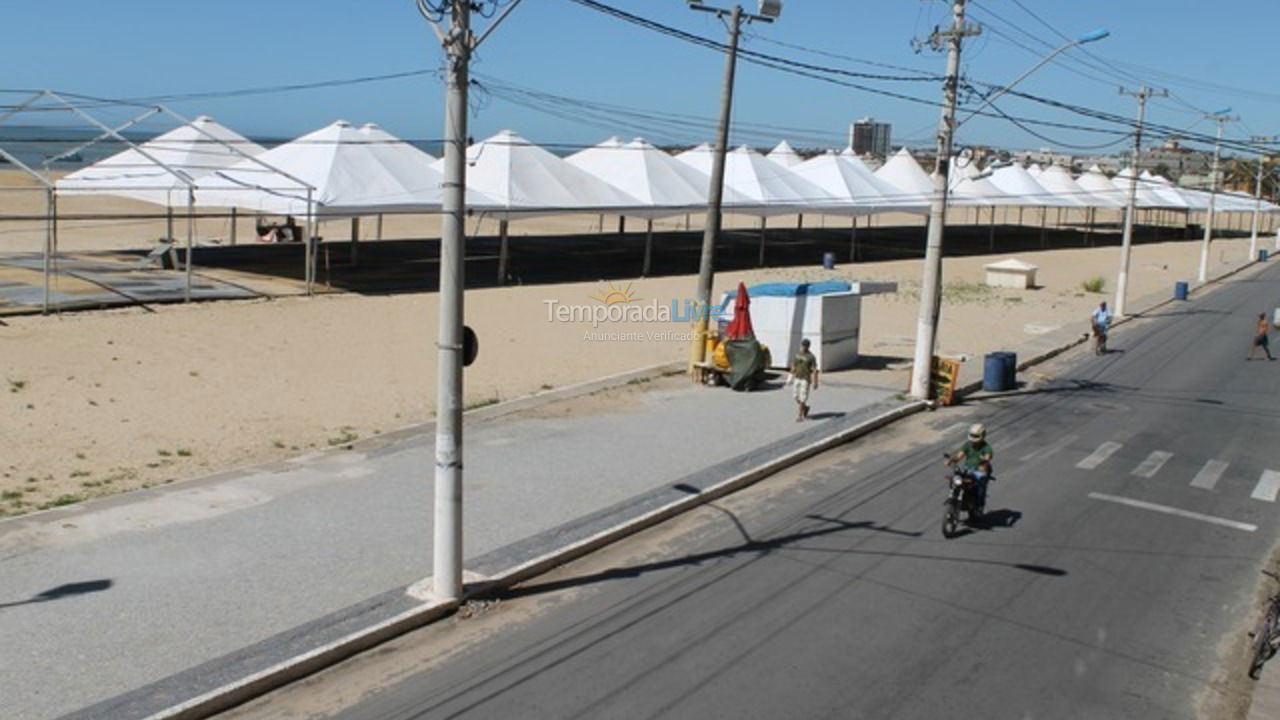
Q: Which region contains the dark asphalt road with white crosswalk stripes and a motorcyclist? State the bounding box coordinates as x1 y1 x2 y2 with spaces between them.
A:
220 260 1280 720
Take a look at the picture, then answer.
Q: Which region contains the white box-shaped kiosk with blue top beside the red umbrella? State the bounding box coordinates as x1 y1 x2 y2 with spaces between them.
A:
721 281 861 372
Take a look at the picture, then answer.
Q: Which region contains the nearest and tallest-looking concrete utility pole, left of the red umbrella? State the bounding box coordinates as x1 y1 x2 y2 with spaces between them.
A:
417 0 520 600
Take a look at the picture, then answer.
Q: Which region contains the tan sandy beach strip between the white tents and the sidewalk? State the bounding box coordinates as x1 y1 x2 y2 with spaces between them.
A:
0 193 1264 514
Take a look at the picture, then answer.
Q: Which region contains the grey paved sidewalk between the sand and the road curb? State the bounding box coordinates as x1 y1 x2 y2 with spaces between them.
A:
0 252 1259 720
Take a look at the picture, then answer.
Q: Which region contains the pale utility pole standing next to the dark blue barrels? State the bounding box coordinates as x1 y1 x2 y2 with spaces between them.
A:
911 0 982 400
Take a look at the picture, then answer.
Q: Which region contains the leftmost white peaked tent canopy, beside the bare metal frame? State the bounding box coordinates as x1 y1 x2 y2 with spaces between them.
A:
55 115 265 206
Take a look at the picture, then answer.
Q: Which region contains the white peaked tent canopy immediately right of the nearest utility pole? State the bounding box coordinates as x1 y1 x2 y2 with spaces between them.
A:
445 129 646 219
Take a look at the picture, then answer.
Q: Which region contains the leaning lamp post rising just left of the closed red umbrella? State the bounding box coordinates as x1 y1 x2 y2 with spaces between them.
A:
689 0 782 374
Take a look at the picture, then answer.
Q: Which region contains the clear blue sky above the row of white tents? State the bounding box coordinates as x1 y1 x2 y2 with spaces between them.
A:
0 0 1280 154
